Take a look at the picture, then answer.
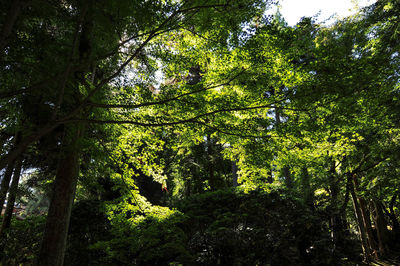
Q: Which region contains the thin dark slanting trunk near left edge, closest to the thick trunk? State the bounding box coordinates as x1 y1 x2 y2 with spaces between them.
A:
0 158 22 236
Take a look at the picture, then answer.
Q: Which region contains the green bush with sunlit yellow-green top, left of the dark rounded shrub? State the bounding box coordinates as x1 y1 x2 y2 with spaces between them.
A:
92 206 191 265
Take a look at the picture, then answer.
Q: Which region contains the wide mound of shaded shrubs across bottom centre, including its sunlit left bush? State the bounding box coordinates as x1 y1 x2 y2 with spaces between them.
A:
93 190 344 265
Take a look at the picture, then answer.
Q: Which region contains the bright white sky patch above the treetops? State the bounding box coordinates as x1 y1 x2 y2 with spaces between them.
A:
280 0 376 26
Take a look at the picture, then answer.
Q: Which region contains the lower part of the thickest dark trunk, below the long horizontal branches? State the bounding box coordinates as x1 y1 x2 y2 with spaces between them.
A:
38 125 83 266
